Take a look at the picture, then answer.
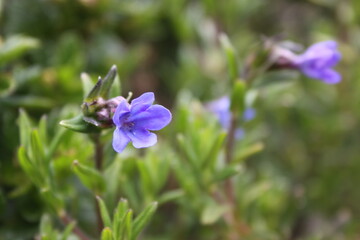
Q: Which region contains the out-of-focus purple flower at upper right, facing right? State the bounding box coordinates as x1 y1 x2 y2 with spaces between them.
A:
295 41 341 84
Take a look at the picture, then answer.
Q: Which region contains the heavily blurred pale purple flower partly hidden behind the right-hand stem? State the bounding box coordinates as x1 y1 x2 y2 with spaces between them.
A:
206 96 256 132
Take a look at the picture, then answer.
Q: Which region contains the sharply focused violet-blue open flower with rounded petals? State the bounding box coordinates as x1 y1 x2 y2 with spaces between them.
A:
112 92 171 153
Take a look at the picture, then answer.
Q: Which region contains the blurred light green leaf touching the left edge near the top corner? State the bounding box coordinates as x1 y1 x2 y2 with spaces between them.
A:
0 35 40 65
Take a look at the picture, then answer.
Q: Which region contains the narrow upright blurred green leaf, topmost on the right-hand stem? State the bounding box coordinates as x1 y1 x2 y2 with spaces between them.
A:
220 34 239 82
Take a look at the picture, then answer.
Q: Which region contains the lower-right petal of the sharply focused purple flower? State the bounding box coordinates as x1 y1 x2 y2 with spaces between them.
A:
126 128 157 148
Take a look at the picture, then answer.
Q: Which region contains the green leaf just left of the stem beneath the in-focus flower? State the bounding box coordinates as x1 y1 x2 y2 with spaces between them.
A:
72 160 105 194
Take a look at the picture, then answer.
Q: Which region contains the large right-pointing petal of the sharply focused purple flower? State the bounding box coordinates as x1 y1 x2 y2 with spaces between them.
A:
129 105 172 131
